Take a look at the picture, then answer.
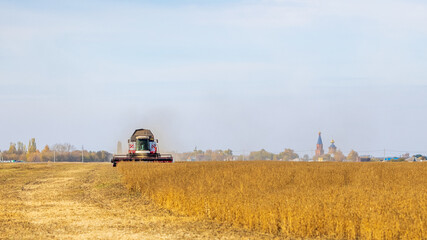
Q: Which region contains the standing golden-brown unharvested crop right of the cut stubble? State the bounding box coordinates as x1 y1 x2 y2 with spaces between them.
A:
119 161 427 239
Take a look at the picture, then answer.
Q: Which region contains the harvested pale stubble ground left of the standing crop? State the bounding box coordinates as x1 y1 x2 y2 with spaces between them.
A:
0 163 271 239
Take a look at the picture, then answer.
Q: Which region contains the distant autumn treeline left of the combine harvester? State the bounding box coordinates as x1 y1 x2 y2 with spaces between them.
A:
0 138 112 162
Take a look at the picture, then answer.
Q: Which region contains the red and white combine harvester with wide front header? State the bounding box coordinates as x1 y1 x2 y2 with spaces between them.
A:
111 128 173 167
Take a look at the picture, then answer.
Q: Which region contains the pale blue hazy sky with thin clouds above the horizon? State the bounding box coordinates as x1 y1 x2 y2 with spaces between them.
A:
0 0 427 156
